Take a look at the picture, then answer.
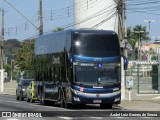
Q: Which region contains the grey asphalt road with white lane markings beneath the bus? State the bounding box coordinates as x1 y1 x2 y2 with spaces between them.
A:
0 95 159 120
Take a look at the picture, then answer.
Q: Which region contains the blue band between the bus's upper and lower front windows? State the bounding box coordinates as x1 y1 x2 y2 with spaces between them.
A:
73 55 121 62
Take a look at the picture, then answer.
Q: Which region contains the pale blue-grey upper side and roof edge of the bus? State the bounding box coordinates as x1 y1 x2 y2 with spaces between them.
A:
34 29 117 55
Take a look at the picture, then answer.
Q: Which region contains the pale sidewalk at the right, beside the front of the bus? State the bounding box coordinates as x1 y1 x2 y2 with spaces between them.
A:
119 90 160 111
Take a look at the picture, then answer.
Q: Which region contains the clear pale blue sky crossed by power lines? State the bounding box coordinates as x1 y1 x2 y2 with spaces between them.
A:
0 0 160 40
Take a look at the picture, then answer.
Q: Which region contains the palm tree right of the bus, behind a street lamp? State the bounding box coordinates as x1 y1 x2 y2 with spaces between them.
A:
127 25 149 59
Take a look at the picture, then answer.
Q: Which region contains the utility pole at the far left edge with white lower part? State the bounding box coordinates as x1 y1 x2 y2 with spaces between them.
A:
0 9 4 92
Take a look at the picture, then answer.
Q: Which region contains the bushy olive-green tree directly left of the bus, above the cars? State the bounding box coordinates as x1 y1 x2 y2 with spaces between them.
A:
14 40 34 71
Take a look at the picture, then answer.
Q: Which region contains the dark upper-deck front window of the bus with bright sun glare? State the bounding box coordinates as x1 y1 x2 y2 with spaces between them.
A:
73 33 120 57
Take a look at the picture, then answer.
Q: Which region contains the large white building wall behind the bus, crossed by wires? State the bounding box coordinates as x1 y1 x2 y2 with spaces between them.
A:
74 0 118 33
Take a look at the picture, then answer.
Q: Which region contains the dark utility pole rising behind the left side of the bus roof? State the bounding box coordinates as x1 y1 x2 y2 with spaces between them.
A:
39 0 43 35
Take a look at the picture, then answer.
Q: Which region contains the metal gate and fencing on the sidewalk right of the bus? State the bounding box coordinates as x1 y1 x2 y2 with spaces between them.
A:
126 61 159 94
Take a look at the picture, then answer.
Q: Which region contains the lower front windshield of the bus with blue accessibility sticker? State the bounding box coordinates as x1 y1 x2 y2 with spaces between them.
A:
74 63 119 85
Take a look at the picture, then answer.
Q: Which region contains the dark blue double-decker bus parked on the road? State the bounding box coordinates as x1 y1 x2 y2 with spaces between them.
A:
35 29 127 108
